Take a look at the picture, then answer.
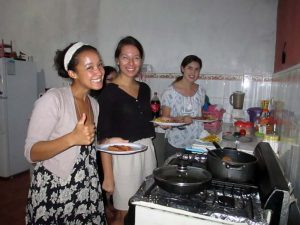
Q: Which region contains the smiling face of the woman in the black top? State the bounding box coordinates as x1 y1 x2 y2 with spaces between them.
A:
116 45 143 77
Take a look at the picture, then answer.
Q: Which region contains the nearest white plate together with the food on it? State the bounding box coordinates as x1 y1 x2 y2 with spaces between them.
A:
96 143 147 155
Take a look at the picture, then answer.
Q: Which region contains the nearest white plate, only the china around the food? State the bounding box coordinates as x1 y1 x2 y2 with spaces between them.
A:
96 143 148 155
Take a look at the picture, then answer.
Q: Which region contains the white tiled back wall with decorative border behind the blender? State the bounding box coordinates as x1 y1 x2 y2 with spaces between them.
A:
140 73 272 122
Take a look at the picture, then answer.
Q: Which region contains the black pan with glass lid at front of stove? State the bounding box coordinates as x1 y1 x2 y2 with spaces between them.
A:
153 161 212 194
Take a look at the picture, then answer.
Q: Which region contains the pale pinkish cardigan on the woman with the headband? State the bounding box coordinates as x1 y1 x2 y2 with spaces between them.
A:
24 87 99 178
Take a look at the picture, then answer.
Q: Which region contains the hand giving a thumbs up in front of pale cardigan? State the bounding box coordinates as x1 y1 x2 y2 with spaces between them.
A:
72 113 96 145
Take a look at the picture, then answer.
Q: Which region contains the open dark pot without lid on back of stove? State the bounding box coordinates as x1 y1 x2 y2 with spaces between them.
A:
207 143 257 183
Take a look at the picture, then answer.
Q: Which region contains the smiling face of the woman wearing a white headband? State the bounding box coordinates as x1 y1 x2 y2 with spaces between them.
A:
69 50 104 90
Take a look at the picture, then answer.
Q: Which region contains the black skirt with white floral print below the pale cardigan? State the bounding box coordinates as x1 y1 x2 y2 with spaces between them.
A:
26 146 106 225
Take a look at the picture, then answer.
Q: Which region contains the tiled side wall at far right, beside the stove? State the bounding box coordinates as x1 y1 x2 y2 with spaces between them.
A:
271 64 300 204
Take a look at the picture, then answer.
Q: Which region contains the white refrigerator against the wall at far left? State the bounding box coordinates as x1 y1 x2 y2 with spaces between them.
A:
0 58 38 177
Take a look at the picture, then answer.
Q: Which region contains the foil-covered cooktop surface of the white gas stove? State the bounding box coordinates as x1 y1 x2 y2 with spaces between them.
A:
132 178 270 225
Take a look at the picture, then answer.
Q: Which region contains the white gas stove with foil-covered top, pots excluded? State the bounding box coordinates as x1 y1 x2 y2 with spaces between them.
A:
127 143 289 225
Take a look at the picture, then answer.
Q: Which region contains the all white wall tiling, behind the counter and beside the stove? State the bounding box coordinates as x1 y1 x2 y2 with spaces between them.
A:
141 69 300 210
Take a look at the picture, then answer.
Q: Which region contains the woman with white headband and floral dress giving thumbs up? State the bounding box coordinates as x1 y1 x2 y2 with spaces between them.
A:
25 42 124 225
